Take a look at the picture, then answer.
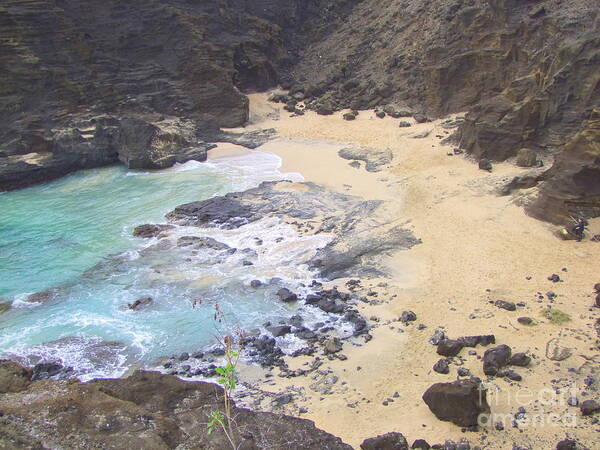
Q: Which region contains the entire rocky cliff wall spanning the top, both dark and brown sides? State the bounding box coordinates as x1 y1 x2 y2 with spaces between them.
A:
0 0 600 221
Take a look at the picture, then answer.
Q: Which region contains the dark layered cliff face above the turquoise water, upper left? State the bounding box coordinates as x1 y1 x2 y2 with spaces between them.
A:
0 0 328 190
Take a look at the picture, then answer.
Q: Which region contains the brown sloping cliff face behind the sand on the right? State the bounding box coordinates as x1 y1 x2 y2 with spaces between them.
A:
282 0 600 222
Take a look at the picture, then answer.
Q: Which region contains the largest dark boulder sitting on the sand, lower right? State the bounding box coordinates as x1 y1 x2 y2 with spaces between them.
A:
423 379 490 427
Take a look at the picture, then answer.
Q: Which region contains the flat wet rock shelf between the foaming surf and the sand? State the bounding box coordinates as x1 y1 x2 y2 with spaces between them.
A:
167 182 421 279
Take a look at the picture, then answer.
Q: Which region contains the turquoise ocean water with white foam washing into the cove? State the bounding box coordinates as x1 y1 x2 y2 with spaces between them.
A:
0 151 328 380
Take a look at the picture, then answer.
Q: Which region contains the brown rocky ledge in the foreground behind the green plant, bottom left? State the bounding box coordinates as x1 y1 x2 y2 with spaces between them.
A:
0 366 351 449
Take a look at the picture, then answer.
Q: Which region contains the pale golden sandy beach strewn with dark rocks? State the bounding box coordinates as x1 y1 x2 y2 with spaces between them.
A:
224 94 600 449
